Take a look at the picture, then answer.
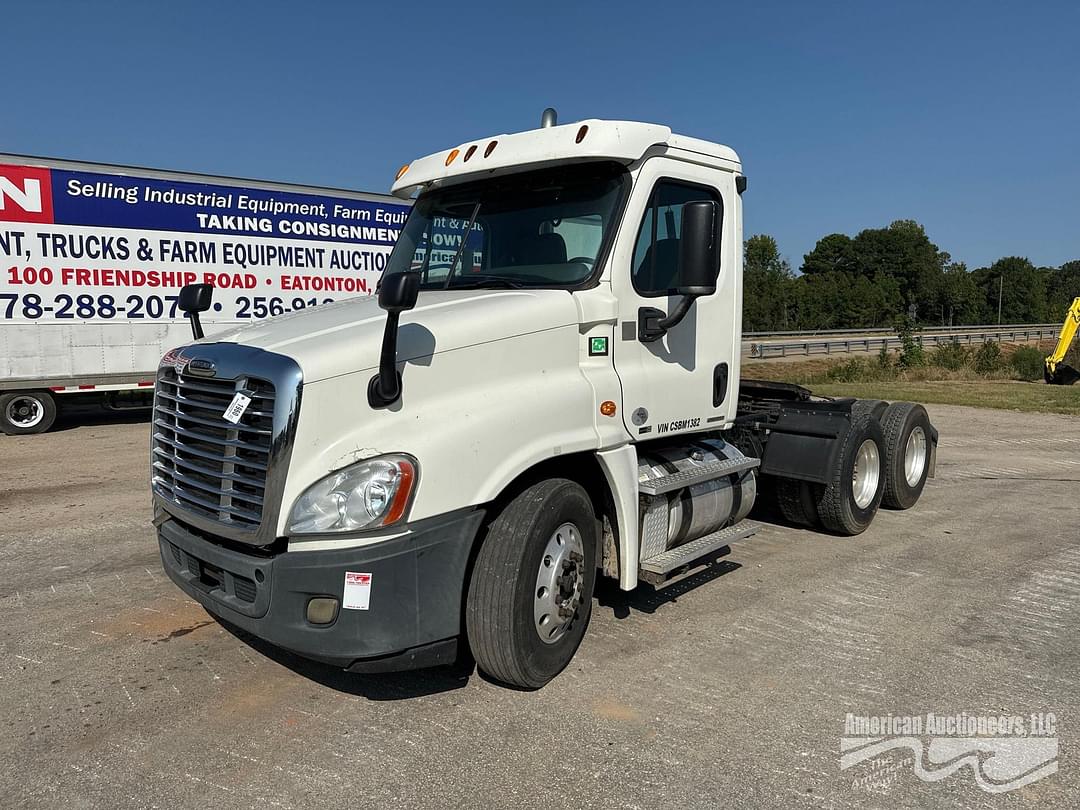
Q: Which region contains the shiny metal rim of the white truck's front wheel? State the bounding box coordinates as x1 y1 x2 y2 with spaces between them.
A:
532 523 585 644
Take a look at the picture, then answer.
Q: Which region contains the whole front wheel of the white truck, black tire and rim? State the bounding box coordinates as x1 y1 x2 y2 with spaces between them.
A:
465 478 596 689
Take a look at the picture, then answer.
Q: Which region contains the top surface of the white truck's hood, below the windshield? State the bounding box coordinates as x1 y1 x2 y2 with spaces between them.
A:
205 289 578 382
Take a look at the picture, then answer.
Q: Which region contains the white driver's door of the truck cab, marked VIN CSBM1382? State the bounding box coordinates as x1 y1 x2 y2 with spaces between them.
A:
610 157 742 441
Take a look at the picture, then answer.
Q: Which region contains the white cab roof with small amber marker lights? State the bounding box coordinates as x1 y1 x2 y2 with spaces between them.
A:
391 119 741 198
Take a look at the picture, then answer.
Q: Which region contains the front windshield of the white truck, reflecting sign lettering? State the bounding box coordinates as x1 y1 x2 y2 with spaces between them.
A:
386 162 630 289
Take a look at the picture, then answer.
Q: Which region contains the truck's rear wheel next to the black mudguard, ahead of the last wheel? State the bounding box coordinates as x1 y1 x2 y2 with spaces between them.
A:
815 415 886 536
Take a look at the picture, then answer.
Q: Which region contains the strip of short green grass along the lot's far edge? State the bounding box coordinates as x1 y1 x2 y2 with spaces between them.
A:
810 380 1080 415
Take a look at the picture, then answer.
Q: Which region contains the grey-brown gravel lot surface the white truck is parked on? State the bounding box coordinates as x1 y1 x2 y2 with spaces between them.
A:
0 407 1080 808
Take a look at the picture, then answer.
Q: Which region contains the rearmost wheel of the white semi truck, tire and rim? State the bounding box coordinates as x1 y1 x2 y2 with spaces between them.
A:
881 402 933 509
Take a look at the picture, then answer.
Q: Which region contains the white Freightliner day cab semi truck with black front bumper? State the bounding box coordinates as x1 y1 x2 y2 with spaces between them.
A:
152 111 937 688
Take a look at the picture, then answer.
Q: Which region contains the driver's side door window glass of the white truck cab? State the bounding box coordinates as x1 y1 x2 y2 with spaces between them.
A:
631 180 720 297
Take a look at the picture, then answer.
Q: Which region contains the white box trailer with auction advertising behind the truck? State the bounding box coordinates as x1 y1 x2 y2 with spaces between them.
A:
0 154 409 433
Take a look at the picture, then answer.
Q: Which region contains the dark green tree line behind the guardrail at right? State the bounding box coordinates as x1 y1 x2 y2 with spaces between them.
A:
743 219 1080 332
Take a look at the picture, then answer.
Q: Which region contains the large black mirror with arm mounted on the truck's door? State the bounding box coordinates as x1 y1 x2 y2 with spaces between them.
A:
637 200 720 343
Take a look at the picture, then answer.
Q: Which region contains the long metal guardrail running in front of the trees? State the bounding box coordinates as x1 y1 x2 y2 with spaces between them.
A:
743 324 1061 360
